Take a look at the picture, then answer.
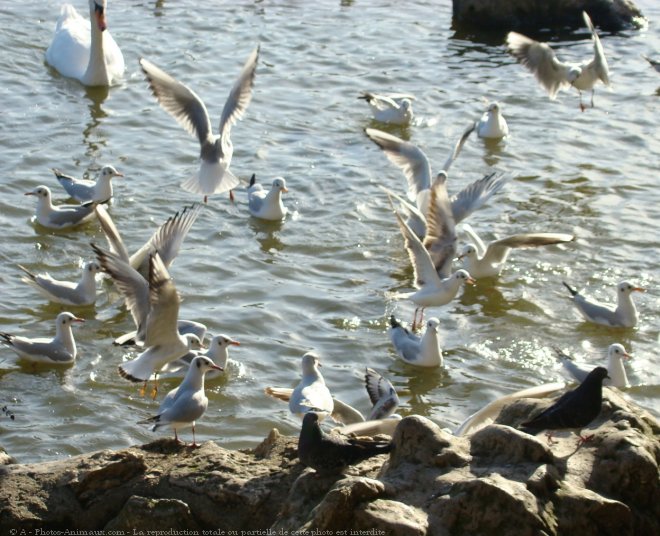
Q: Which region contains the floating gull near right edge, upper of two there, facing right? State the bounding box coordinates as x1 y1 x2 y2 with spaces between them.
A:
564 281 645 328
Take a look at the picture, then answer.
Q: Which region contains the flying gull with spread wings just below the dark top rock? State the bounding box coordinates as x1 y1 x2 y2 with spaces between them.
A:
506 11 610 111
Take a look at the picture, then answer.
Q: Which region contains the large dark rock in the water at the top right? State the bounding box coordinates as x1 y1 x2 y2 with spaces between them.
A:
452 0 644 32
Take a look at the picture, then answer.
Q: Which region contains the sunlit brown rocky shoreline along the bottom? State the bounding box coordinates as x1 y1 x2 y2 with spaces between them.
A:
0 388 660 536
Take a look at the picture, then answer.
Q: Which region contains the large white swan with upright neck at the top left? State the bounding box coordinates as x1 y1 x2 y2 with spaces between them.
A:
46 0 124 86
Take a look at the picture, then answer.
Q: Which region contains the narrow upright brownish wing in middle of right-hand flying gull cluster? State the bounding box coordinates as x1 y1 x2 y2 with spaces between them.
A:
423 174 456 278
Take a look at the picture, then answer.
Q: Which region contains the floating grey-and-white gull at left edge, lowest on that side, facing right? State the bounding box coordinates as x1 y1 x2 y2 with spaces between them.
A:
0 312 84 365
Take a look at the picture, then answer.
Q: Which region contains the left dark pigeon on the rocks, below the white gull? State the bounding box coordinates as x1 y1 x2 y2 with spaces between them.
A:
298 411 392 476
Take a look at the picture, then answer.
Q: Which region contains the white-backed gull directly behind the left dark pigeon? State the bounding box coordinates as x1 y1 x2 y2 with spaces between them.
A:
289 352 334 418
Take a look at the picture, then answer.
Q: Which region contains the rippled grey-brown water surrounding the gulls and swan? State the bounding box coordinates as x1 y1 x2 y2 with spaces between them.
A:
0 0 660 461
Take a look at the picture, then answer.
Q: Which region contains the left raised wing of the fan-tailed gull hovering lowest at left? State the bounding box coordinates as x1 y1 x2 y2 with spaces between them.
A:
92 244 151 341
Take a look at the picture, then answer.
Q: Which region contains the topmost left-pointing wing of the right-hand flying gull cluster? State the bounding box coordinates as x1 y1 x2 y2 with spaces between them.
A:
364 128 431 201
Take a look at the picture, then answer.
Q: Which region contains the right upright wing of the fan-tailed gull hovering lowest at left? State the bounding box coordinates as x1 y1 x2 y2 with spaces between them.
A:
144 252 181 347
